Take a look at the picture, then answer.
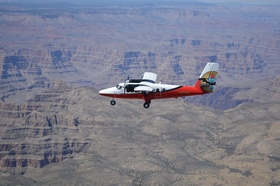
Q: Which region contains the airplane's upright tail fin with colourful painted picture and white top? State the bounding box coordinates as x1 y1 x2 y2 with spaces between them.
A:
195 62 219 93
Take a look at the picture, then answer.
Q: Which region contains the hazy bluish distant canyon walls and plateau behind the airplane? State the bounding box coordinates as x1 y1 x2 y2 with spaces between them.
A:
0 4 280 108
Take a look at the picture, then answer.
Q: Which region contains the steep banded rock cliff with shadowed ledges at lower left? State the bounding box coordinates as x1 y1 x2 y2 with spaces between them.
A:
0 82 89 174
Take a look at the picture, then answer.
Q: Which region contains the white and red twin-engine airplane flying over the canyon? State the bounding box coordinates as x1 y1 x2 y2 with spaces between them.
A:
99 62 219 109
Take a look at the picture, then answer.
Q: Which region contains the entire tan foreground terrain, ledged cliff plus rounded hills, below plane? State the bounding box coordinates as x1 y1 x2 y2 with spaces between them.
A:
0 82 280 185
